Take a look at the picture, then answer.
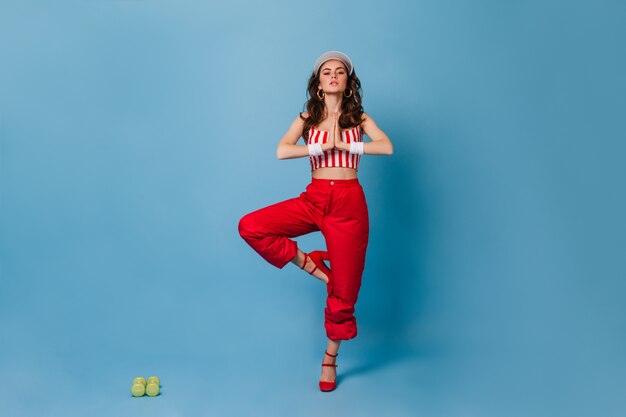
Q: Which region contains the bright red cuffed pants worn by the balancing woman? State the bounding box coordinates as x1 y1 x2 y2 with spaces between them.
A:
239 178 369 340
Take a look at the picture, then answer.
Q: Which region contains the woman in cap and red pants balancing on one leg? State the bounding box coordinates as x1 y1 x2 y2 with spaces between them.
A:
239 51 393 391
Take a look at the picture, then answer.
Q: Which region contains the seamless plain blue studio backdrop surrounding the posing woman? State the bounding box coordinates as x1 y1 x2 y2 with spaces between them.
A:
0 0 626 416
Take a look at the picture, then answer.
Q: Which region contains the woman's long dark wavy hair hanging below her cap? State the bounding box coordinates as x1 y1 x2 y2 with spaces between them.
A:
300 68 363 142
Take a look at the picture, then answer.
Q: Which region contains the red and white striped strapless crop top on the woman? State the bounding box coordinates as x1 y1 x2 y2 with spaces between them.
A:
308 126 363 171
